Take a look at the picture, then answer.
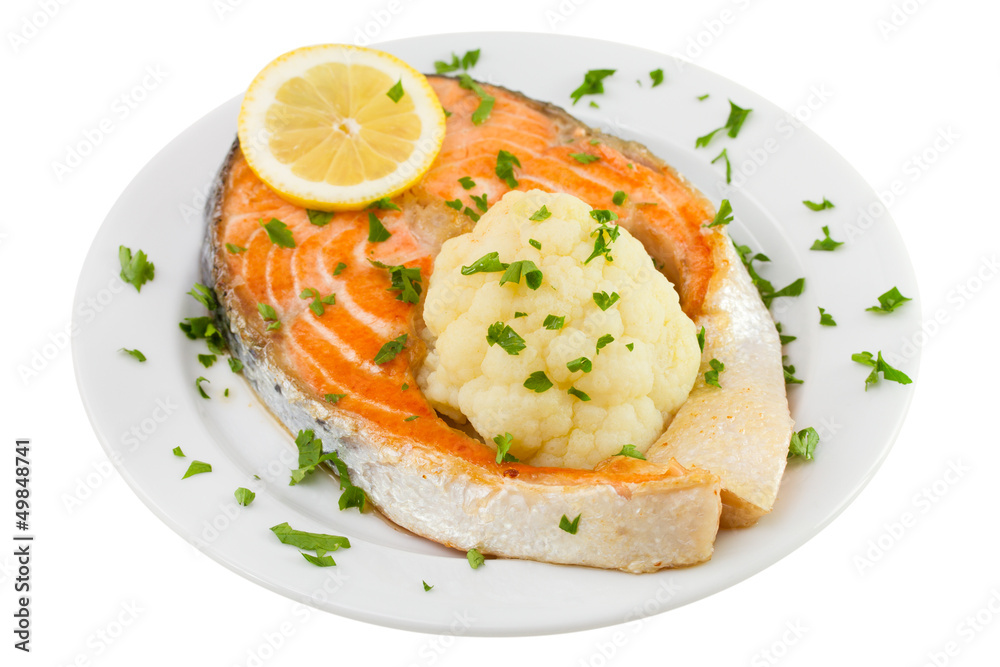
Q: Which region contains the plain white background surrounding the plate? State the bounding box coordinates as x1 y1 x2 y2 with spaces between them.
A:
0 0 1000 666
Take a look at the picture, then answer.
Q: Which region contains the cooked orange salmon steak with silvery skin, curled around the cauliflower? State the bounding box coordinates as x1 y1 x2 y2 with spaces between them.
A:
203 76 791 573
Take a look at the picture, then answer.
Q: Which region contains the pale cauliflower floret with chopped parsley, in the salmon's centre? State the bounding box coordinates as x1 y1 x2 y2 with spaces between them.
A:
417 190 701 468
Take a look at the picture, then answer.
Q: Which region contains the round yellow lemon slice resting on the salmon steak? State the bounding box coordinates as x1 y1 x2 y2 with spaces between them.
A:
239 44 445 211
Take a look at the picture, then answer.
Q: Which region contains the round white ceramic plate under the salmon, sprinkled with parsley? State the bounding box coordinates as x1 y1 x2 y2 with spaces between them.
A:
73 33 920 635
